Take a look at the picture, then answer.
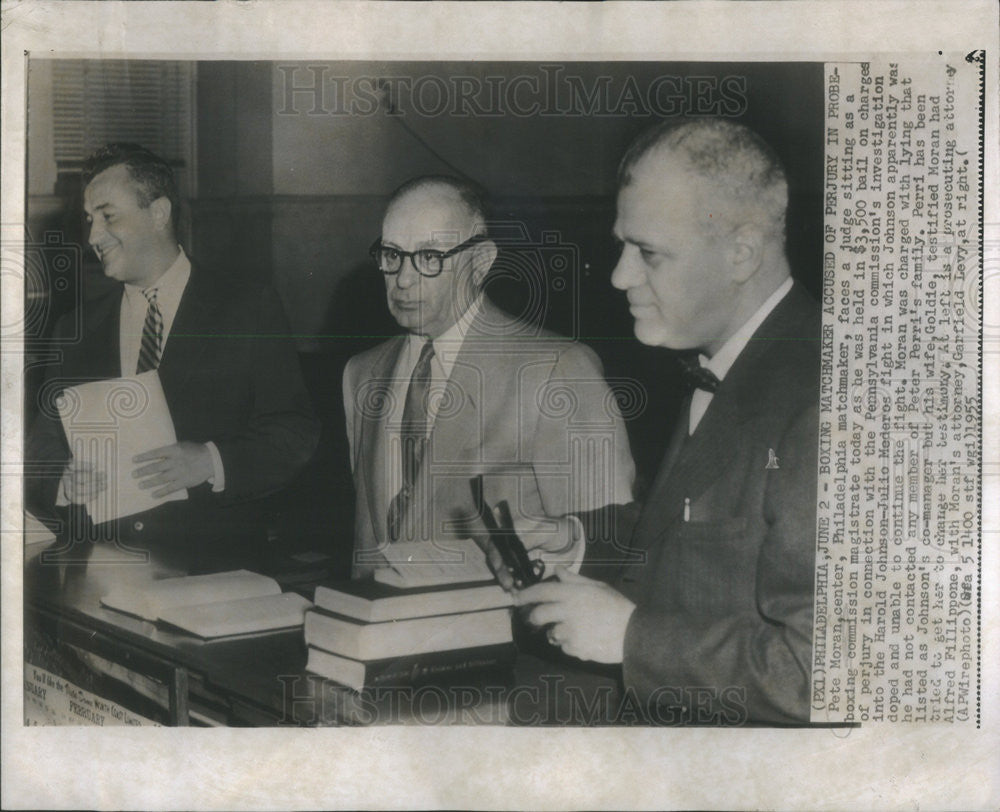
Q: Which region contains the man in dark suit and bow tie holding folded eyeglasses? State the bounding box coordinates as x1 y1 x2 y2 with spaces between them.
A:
517 120 820 724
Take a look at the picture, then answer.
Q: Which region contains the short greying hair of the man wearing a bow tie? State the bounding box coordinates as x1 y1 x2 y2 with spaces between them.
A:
618 118 788 237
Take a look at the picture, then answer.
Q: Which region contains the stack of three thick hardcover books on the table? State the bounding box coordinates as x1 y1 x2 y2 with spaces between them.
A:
305 580 514 691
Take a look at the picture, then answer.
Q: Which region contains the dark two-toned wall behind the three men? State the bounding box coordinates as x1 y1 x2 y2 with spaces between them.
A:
29 62 823 576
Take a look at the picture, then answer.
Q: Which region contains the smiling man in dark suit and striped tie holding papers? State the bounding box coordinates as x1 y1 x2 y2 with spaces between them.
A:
25 144 318 572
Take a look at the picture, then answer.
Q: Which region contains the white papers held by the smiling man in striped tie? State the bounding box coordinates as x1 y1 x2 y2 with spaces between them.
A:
57 370 187 523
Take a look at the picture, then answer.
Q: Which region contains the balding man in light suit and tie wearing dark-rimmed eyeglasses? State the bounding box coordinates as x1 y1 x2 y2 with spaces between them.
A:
344 176 634 577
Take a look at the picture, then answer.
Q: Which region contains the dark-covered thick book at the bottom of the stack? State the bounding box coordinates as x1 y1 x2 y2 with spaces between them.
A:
306 643 517 691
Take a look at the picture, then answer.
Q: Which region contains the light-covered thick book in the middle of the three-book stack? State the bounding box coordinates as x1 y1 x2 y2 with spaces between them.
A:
305 607 514 660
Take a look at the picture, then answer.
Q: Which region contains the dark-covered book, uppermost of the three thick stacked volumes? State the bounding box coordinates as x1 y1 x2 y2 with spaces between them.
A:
314 579 512 623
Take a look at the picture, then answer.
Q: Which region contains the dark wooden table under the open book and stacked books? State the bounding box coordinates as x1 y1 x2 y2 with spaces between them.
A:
25 561 616 726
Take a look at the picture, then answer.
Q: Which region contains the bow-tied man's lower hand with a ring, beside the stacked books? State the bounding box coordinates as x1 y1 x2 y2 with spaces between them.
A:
514 567 635 663
